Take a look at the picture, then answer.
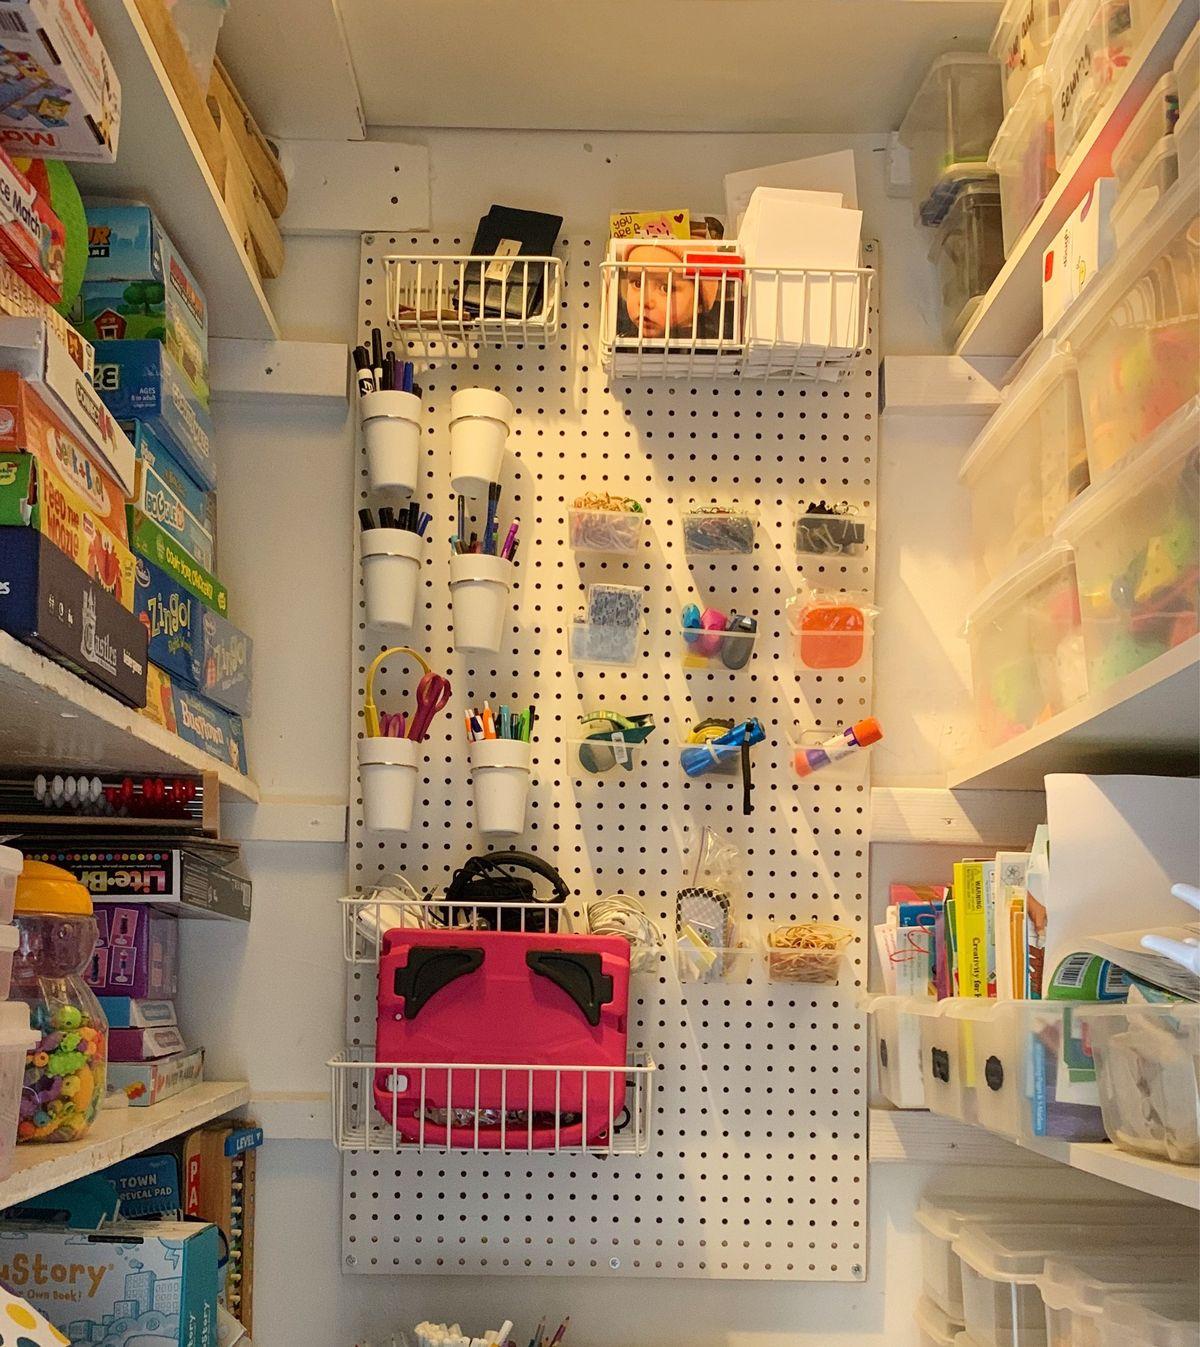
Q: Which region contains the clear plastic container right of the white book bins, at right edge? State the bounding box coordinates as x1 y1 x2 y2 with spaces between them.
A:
1081 1004 1200 1165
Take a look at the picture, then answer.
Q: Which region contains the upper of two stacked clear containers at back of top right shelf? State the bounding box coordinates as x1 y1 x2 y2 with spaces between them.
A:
900 51 1003 225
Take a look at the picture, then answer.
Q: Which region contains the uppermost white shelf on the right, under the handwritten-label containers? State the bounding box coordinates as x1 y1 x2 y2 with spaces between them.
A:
955 0 1200 357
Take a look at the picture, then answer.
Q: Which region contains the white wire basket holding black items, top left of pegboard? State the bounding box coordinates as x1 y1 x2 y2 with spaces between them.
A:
384 253 563 356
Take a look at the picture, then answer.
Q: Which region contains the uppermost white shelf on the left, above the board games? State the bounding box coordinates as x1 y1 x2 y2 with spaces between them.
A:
71 0 279 341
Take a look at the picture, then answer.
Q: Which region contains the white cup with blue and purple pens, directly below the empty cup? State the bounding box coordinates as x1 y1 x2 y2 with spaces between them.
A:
450 482 520 653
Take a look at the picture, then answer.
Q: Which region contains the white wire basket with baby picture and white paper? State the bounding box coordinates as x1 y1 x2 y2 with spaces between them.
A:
601 261 874 383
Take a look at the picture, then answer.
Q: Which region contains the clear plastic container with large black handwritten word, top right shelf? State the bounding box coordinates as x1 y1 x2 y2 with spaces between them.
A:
1046 0 1162 172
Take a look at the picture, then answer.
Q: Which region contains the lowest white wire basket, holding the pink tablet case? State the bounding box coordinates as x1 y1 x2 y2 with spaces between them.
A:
329 1044 656 1156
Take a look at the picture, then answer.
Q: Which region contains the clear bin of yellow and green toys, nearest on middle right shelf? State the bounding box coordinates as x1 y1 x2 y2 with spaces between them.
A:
1059 401 1200 692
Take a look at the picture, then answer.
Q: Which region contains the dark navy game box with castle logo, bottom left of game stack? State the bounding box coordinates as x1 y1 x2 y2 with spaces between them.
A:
0 528 148 707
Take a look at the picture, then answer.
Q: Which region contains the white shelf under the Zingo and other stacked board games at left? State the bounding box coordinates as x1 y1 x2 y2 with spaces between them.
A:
0 632 259 800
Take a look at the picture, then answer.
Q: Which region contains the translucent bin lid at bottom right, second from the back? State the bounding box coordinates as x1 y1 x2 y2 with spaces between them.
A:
954 1208 1200 1286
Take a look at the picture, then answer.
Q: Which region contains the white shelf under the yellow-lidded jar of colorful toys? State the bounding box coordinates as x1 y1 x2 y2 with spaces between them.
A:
0 1080 251 1207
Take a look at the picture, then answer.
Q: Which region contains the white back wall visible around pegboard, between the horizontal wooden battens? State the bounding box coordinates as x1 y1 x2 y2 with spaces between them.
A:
183 132 1098 1347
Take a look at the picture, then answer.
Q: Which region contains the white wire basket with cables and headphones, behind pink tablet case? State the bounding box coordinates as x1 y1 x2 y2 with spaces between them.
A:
338 889 587 967
